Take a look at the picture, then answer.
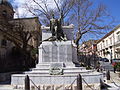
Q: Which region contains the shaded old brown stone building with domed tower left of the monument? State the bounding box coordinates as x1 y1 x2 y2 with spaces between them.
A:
0 0 42 67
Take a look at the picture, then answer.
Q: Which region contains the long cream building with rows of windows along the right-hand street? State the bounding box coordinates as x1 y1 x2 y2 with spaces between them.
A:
97 25 120 61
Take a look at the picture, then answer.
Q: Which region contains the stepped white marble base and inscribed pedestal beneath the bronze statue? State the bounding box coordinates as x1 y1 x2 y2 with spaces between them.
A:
11 41 103 90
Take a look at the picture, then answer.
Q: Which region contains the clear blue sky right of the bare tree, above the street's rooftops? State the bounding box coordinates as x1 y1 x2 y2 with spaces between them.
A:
82 0 120 42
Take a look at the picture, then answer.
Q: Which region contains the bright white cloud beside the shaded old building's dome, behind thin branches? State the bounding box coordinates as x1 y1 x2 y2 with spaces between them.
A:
13 0 60 17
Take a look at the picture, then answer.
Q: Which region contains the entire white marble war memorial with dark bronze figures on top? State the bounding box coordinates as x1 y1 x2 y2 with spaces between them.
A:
11 17 103 90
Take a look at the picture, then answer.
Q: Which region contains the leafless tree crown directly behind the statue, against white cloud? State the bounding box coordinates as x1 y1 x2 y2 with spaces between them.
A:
25 0 74 25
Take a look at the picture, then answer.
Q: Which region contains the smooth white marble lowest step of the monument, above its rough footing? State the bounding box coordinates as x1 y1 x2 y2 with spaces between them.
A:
11 72 103 85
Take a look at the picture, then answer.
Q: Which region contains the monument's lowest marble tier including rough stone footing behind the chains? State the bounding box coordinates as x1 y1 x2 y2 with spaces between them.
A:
11 72 103 90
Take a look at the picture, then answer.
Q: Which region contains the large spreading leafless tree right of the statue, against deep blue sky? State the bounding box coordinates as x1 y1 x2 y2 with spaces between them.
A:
69 0 113 47
